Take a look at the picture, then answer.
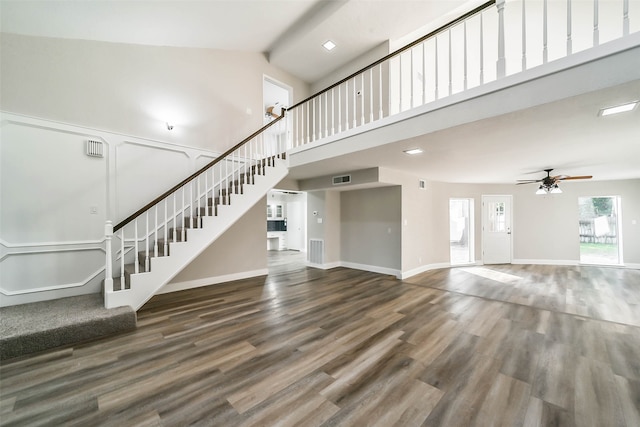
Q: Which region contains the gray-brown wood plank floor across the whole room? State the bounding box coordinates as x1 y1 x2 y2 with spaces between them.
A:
0 252 640 427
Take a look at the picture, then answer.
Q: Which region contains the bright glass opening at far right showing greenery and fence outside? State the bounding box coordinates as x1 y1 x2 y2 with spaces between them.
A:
578 196 622 265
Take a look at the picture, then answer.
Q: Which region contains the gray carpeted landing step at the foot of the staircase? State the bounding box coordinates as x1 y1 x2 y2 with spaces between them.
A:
0 294 136 360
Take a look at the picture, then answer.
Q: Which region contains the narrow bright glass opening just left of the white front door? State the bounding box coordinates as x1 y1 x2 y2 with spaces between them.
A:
449 199 474 265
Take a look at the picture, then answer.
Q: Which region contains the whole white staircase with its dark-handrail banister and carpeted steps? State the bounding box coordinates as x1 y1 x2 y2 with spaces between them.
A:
104 119 288 310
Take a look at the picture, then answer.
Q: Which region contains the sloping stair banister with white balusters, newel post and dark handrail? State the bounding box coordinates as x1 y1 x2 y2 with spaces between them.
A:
105 114 286 292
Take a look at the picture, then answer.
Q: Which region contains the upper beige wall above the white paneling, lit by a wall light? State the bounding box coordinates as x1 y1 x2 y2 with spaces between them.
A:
0 33 309 151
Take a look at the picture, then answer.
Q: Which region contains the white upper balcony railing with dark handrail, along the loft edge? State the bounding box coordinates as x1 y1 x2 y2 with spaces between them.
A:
287 0 640 148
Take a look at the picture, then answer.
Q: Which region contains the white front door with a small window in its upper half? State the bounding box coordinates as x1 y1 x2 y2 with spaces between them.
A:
482 196 512 264
